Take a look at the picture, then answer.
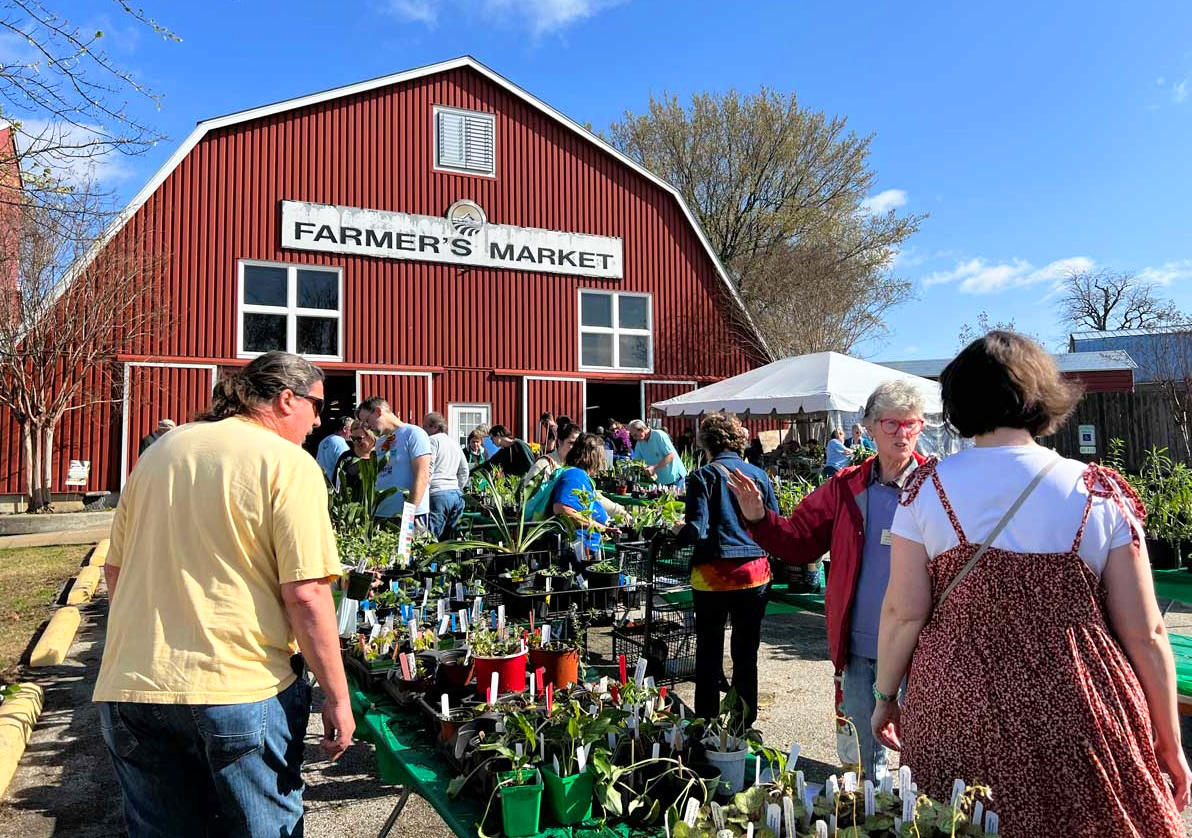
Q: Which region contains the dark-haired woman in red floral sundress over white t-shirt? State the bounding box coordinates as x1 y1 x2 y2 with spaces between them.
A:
873 331 1190 838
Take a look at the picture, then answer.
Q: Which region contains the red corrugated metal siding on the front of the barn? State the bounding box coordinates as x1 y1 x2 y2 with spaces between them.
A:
0 67 764 488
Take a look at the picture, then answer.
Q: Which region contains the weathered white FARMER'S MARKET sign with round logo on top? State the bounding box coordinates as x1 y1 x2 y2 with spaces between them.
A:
281 200 625 279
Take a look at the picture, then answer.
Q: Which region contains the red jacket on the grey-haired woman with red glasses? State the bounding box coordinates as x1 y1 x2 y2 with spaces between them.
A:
749 453 925 675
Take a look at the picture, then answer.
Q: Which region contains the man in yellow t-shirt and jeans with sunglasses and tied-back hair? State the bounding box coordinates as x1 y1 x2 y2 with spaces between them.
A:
94 352 355 838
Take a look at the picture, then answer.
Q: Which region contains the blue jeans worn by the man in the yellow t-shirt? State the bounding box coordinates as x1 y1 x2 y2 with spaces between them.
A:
99 678 310 838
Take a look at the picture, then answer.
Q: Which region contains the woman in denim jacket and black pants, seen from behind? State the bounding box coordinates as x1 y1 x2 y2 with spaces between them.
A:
678 412 778 725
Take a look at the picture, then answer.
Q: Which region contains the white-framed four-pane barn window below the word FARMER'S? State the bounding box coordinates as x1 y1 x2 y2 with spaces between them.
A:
236 259 343 361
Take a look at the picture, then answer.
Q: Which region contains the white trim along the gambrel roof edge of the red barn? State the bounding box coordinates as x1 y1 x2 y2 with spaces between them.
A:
51 55 775 360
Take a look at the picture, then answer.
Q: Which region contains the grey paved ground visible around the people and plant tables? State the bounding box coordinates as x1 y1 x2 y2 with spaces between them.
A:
0 586 1192 838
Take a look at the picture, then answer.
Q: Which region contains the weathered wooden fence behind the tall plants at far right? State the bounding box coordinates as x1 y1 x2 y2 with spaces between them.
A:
1042 385 1192 471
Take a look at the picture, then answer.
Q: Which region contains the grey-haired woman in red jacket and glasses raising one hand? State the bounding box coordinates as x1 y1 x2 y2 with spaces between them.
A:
731 380 923 783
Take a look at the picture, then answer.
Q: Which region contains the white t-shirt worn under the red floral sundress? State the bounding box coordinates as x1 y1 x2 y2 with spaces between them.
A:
890 445 1137 576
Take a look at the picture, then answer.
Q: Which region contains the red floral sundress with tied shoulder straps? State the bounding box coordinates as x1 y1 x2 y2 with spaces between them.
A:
901 461 1185 838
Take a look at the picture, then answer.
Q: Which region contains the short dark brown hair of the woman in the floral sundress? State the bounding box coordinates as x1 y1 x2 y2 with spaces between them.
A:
939 331 1081 436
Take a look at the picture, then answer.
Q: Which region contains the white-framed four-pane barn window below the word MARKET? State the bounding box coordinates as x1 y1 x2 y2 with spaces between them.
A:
579 288 654 372
